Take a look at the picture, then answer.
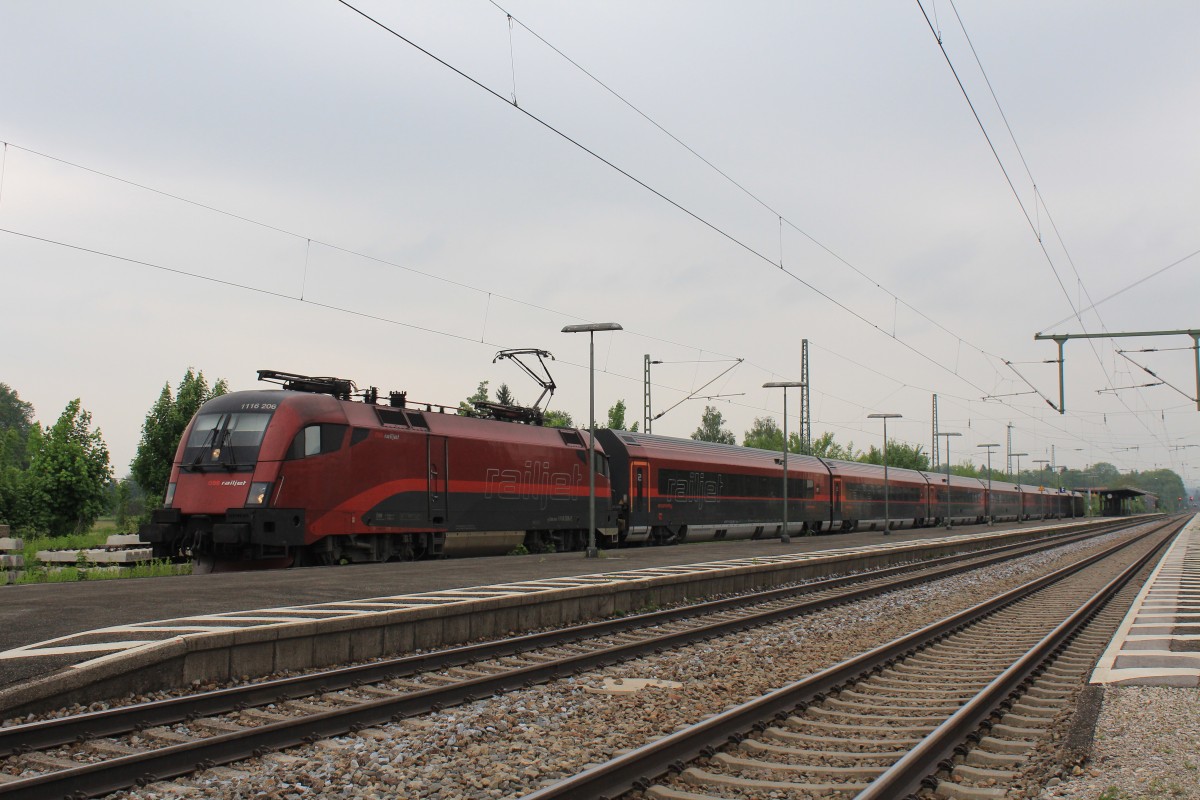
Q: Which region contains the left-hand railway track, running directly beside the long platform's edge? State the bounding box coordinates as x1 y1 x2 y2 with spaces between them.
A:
0 520 1152 799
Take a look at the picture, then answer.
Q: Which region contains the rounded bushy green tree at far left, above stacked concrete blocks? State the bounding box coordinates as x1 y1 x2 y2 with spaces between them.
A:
26 398 113 534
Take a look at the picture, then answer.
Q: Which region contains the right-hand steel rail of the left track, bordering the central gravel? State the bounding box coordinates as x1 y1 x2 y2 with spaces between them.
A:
0 515 1142 800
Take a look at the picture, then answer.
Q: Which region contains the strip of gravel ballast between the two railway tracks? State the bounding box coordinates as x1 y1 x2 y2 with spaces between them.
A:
93 527 1169 800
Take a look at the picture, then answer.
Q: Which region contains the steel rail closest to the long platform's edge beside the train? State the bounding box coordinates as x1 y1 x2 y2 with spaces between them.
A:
0 525 1112 758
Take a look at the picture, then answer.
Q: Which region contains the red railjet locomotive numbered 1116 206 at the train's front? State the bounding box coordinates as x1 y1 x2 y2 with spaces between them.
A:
140 379 616 566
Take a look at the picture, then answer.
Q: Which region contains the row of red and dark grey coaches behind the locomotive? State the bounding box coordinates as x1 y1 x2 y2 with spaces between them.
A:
596 431 1084 543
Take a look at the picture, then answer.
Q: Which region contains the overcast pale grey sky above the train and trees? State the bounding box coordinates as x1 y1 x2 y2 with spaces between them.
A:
0 0 1200 483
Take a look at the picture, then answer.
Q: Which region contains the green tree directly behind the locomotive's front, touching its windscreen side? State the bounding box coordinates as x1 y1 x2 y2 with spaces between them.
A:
130 367 229 505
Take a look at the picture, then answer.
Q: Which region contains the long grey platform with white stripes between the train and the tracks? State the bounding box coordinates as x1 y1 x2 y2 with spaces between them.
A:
0 519 1099 711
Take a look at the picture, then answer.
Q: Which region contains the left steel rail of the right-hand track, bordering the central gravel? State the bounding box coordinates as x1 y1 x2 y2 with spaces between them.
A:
522 521 1182 800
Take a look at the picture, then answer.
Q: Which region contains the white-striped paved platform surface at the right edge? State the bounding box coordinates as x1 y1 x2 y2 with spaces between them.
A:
1092 515 1200 687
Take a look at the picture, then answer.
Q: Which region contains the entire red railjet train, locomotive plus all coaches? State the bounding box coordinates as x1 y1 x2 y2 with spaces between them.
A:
140 371 1082 569
